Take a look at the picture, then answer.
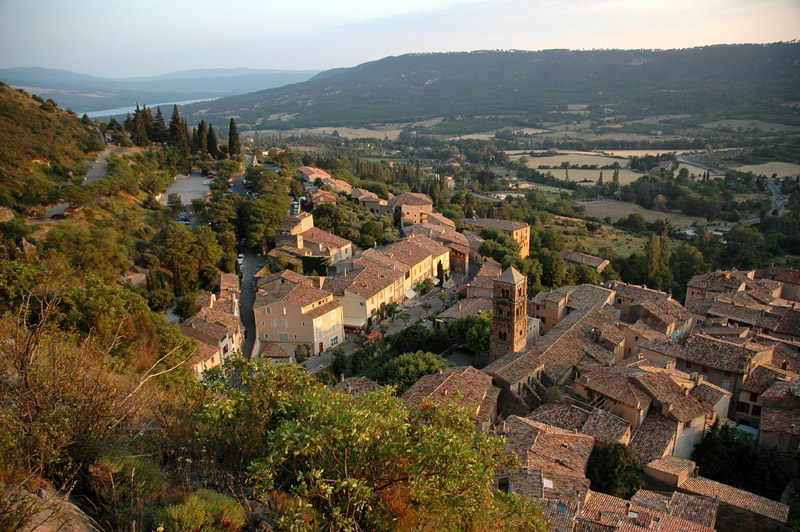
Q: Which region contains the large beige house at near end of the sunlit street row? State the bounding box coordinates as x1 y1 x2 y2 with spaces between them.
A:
253 279 345 353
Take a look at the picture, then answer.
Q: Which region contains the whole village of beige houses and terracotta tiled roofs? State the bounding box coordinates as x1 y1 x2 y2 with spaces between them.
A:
175 160 800 531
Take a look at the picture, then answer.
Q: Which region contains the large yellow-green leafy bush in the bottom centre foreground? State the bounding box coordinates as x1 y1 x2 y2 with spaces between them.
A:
201 359 542 530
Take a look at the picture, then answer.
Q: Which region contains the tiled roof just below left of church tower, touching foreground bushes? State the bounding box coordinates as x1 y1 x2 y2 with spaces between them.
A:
402 366 500 422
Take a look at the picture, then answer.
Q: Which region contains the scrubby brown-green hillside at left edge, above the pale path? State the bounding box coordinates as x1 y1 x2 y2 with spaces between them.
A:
0 84 103 208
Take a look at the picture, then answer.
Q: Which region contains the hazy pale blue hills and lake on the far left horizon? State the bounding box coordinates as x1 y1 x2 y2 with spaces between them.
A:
0 67 319 114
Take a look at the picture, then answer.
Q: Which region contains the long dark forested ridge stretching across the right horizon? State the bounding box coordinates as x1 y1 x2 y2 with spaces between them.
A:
182 43 800 130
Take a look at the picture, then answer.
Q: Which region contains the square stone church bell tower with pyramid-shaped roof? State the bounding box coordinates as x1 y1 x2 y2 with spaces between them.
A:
489 266 528 363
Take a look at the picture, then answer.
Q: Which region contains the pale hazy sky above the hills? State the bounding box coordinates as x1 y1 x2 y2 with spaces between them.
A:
0 0 800 77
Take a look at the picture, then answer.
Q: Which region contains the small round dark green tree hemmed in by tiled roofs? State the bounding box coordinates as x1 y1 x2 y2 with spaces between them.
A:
586 442 644 499
